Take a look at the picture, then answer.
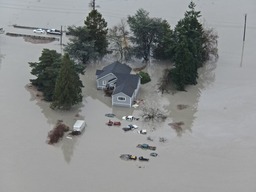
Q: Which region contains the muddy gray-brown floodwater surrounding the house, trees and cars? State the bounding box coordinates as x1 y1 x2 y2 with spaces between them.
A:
0 0 256 192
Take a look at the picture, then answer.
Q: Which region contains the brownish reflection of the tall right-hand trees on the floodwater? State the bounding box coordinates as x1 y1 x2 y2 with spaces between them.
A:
135 62 216 136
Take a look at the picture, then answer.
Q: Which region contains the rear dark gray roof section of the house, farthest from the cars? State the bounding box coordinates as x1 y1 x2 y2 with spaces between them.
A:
96 61 132 78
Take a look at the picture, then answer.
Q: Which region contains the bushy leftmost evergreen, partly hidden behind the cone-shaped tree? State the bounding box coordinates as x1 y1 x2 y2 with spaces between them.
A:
29 49 61 101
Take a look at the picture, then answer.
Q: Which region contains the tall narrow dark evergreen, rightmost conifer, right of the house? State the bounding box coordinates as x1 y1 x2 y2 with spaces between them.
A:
170 1 203 90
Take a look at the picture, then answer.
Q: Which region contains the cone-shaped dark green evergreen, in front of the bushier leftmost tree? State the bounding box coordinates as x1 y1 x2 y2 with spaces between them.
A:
51 53 83 110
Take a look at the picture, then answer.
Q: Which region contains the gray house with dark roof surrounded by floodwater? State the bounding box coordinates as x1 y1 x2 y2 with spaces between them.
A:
96 61 140 107
